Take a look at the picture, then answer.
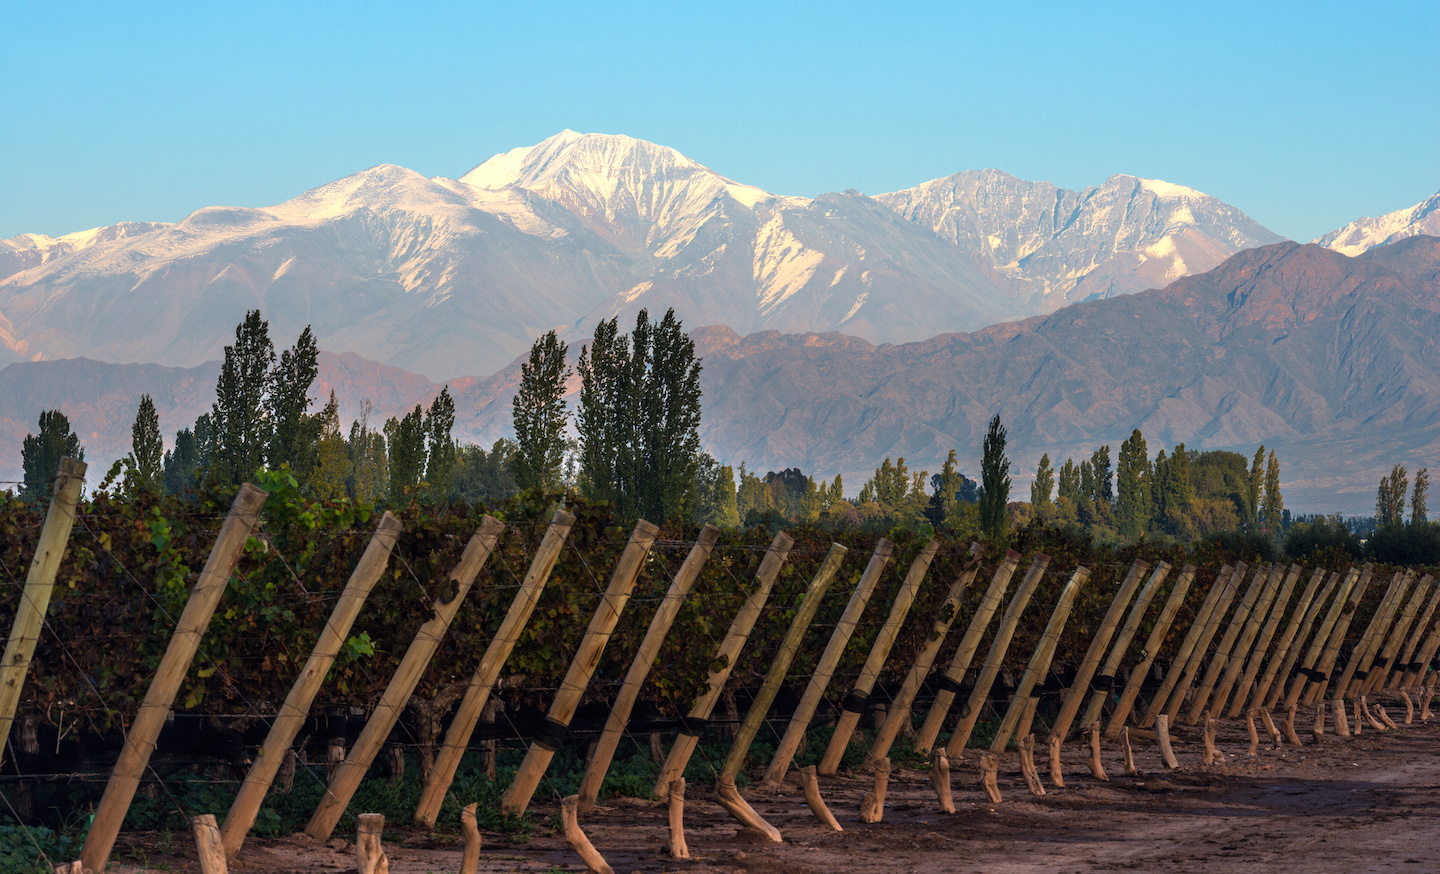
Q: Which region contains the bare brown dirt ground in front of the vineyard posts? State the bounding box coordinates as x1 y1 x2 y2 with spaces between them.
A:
112 703 1440 874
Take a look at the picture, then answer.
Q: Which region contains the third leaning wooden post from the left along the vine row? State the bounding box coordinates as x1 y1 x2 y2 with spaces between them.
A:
220 510 405 858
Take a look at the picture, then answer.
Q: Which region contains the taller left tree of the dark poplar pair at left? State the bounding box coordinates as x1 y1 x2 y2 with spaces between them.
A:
209 310 275 484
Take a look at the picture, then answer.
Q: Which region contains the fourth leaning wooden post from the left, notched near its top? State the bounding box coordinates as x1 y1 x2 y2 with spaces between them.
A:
305 515 505 841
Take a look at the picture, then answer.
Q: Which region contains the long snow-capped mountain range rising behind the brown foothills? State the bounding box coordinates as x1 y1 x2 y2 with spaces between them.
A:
0 131 1277 379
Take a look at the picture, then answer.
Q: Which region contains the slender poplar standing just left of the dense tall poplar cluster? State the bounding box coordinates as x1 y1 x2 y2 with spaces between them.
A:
511 331 570 490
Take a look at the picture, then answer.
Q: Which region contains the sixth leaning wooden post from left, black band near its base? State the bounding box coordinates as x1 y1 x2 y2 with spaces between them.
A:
500 520 660 816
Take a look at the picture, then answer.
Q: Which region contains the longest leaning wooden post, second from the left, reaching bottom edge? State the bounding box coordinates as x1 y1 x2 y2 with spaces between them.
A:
81 482 268 874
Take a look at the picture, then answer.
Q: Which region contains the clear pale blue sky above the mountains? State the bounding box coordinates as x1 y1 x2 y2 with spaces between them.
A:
0 1 1440 239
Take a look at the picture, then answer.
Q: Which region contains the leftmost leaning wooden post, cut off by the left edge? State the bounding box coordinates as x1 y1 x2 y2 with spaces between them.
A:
0 458 85 752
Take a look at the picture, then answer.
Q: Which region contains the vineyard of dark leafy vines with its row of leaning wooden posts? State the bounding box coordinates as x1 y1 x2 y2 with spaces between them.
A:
0 462 1440 873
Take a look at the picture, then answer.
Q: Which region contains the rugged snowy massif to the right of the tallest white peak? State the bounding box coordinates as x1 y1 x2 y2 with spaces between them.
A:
877 170 1283 311
